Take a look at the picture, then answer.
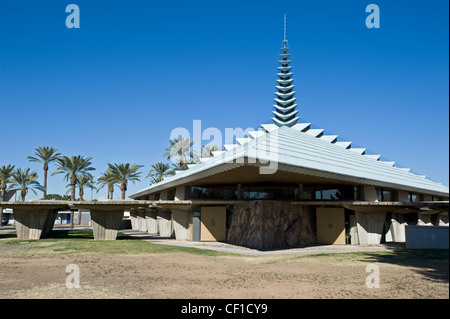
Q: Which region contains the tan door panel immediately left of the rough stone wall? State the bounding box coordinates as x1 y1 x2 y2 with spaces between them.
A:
200 207 227 241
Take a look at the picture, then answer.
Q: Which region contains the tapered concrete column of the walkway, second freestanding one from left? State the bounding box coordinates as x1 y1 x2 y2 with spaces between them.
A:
91 209 123 240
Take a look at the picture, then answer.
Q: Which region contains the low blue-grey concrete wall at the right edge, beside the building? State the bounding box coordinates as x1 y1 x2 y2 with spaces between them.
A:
405 226 449 249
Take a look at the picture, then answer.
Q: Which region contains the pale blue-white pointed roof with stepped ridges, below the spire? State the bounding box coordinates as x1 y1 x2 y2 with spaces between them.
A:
130 123 449 198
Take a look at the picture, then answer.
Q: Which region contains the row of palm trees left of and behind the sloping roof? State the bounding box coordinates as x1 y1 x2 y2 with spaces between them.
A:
0 137 221 204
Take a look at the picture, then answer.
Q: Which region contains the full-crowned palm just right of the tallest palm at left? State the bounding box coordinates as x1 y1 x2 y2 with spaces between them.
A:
52 155 95 201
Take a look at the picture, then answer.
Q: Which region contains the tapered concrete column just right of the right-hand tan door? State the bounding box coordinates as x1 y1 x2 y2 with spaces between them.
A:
355 212 386 245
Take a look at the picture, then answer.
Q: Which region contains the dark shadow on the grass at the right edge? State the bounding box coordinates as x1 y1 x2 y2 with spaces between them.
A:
364 249 449 283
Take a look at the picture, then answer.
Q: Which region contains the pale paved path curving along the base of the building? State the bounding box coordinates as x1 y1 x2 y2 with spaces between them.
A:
120 229 404 256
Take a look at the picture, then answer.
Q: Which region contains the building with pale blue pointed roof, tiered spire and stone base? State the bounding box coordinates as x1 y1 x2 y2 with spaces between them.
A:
130 19 449 249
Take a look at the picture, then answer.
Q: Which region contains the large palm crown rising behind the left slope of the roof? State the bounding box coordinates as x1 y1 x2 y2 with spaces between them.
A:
164 137 198 170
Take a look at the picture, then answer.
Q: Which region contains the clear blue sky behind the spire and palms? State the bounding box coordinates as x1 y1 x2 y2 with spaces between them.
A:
0 0 449 199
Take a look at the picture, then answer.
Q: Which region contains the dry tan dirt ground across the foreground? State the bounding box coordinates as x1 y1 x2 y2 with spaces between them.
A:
0 242 449 299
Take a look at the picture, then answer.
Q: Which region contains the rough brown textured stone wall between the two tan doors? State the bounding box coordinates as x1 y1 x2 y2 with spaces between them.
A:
227 200 316 250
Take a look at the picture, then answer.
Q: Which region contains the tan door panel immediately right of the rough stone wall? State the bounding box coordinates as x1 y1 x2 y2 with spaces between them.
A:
316 208 345 245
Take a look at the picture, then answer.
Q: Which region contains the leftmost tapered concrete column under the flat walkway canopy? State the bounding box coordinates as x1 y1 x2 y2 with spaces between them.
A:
14 208 54 240
